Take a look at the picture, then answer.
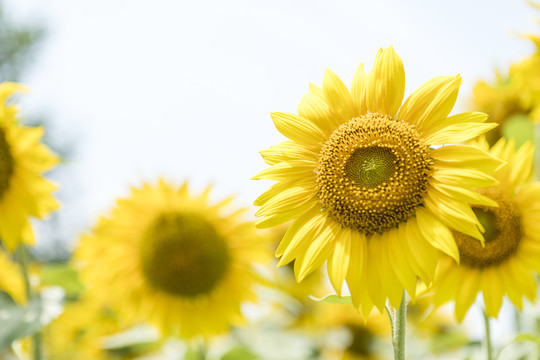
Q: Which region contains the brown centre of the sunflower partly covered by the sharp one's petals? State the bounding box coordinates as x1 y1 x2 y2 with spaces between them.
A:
454 189 521 268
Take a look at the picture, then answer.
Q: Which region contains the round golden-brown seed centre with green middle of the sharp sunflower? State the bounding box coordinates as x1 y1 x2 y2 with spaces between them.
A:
316 113 433 235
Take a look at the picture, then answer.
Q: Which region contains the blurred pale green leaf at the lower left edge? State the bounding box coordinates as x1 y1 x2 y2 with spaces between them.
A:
0 292 42 351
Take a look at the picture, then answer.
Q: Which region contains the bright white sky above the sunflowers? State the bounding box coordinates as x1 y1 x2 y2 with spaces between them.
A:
4 0 540 230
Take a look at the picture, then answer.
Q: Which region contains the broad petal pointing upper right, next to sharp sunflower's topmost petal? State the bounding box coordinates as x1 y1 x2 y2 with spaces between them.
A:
398 75 461 132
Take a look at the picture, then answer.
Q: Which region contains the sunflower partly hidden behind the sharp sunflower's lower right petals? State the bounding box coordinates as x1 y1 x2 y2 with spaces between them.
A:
434 139 540 321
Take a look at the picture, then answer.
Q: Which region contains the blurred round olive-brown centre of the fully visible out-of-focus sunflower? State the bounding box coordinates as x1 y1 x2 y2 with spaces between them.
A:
140 213 231 297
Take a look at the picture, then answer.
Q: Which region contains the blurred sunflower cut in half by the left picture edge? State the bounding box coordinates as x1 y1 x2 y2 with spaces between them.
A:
0 82 58 251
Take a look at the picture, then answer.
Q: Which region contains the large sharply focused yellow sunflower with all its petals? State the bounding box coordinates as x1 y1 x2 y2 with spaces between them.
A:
254 47 501 316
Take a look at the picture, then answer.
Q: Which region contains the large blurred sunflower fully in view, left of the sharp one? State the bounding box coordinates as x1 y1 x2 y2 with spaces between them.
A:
75 180 268 338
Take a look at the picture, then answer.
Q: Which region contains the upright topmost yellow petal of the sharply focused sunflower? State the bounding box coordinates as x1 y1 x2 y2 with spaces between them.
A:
366 46 405 117
